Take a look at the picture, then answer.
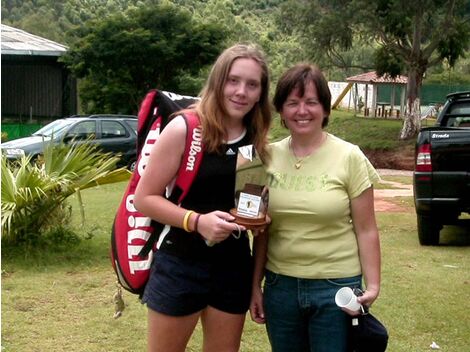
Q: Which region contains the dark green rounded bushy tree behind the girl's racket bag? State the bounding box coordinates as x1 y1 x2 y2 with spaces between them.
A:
62 2 226 113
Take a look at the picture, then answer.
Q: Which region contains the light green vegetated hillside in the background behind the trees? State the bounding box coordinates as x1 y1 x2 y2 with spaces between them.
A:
1 0 470 84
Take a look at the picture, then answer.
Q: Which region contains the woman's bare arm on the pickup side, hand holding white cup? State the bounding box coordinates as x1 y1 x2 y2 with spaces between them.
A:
351 186 381 306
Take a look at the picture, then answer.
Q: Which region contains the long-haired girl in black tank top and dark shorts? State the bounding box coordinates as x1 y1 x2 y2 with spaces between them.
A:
134 44 271 352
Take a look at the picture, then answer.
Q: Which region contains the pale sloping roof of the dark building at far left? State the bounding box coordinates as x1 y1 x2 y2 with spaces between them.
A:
1 24 68 56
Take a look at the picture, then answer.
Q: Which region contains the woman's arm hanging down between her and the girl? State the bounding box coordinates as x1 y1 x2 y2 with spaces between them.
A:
250 230 268 324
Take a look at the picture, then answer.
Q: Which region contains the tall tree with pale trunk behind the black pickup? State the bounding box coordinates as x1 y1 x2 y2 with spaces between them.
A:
283 0 470 139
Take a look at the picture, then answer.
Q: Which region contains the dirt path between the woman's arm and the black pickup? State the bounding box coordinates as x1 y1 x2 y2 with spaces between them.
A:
374 169 413 212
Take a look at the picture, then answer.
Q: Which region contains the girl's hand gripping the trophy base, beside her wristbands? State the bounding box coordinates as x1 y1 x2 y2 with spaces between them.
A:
198 210 246 243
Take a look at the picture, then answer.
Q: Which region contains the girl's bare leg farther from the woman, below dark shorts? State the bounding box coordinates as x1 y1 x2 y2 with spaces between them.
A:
147 309 201 352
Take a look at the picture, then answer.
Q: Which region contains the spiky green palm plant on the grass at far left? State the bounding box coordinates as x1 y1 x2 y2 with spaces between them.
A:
1 139 129 243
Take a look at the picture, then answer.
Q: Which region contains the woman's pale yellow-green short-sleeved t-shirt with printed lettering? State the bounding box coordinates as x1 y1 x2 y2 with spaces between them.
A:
266 134 379 279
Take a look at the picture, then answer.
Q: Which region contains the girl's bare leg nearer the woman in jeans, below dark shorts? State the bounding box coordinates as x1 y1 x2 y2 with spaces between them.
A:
201 306 245 352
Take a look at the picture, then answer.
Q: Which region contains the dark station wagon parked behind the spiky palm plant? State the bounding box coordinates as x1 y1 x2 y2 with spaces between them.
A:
1 114 137 170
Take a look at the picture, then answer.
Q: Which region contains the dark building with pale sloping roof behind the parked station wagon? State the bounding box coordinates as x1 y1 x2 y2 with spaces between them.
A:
1 24 77 123
